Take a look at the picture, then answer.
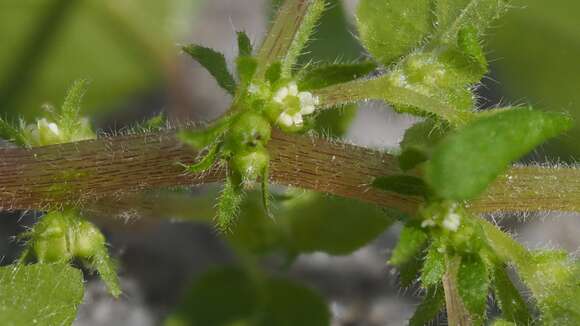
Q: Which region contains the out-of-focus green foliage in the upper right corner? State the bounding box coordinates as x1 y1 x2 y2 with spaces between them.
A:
489 0 580 160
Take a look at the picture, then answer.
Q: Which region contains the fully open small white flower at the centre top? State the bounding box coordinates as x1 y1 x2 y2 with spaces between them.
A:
272 82 319 127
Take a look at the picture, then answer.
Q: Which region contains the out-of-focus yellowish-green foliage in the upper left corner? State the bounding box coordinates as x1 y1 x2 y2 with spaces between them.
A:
0 0 198 118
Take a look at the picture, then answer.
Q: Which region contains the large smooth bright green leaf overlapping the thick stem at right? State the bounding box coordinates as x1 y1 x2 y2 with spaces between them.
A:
425 109 572 200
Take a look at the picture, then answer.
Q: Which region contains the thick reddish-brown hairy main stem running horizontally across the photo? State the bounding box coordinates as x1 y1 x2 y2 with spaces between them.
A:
0 131 580 213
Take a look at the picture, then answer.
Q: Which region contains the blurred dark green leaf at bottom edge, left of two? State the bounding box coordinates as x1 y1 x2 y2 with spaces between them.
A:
165 267 259 326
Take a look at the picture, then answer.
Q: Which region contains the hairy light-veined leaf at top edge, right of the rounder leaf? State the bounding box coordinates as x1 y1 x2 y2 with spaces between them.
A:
434 0 511 42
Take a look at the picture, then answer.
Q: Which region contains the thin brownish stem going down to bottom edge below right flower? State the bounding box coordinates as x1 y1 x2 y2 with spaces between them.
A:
443 256 473 326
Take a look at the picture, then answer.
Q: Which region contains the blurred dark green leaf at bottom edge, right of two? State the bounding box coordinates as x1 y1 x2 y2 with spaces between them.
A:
260 278 330 326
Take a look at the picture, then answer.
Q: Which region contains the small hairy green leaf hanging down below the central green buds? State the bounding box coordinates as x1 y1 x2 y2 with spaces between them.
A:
216 176 244 232
